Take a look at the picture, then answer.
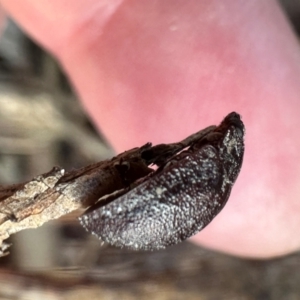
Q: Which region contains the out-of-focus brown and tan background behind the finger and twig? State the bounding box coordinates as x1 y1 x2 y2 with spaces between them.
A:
0 0 300 300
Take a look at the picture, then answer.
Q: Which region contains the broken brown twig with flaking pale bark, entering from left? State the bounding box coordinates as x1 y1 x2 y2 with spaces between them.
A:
0 144 153 256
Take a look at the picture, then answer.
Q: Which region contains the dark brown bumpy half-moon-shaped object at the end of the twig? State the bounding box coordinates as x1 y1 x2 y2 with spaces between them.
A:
80 113 244 250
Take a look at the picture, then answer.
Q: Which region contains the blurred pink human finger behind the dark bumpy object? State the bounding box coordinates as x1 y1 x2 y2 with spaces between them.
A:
0 0 300 257
